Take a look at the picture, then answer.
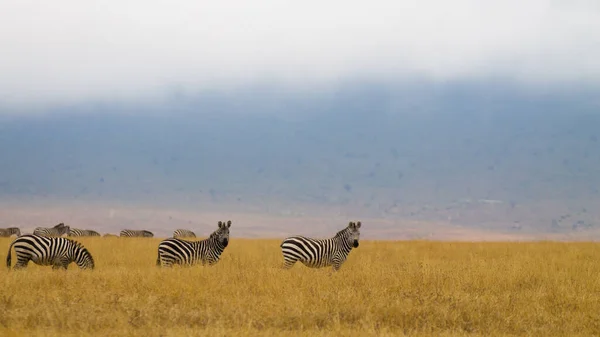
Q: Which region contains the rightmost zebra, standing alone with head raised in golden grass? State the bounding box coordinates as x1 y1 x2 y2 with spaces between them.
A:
280 221 361 271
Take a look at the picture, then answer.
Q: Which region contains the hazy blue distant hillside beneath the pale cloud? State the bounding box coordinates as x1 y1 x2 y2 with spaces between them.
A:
0 84 600 232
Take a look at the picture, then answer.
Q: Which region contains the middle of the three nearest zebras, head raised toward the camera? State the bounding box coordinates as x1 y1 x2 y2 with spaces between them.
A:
156 220 231 267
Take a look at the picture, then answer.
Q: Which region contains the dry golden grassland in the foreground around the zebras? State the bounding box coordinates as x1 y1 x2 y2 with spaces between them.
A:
0 236 600 337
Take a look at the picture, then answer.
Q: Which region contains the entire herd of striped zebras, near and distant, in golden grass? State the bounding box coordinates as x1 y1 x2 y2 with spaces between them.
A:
0 220 361 271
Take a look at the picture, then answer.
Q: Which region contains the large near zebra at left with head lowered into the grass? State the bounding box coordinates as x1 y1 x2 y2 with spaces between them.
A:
6 234 94 269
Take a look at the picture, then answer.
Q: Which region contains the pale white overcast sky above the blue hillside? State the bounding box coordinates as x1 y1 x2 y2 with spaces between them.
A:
0 0 600 105
